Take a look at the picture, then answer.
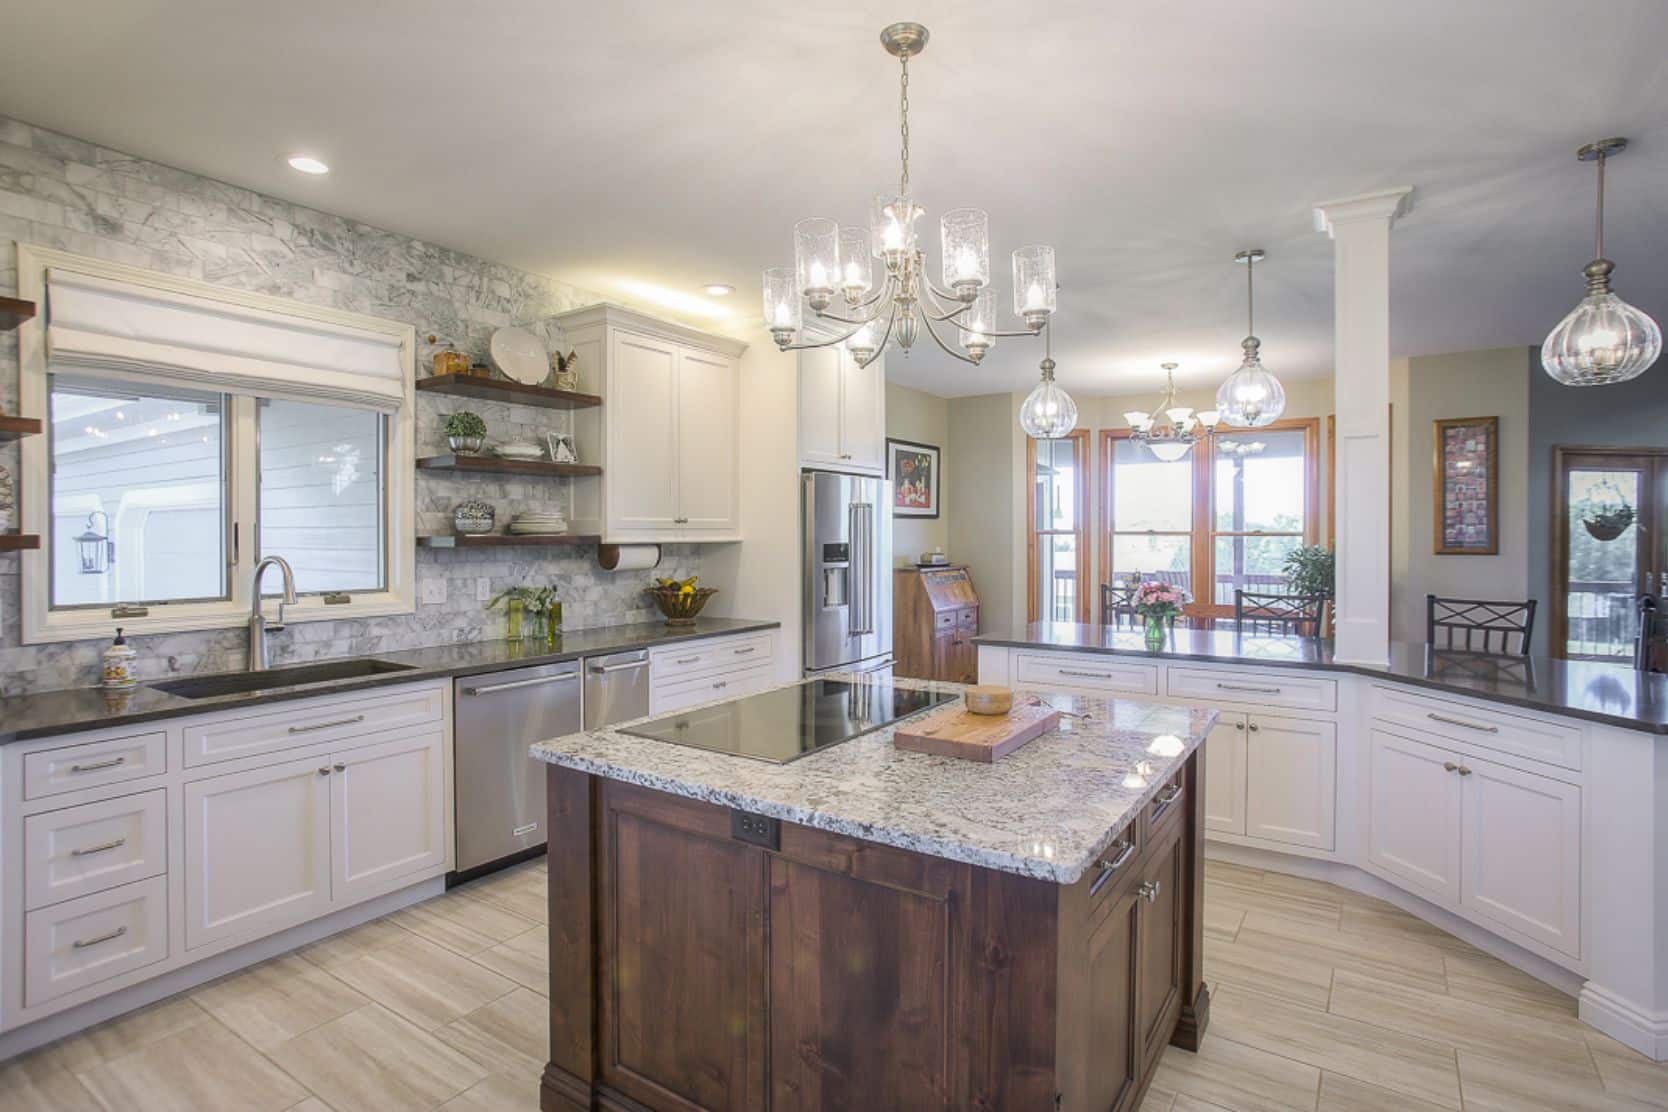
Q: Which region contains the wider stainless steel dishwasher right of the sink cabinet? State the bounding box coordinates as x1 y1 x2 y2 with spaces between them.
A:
450 660 582 884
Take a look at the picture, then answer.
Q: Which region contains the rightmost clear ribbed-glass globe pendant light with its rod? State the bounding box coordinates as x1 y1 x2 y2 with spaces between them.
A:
1541 138 1663 387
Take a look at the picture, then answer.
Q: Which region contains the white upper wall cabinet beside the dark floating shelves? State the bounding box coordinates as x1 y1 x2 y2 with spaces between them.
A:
557 305 747 542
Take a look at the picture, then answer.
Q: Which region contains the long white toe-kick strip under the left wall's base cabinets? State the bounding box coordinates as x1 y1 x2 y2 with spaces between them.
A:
0 877 445 1062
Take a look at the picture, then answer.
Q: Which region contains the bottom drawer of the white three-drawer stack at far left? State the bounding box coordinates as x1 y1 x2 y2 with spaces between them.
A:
23 877 168 1007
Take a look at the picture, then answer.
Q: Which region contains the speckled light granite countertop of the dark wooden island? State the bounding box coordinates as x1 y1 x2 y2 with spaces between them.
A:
532 675 1216 884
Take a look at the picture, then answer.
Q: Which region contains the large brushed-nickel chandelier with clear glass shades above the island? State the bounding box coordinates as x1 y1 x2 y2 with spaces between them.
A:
764 23 1054 373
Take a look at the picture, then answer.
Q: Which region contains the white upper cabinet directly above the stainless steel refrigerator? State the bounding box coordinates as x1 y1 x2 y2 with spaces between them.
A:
799 345 886 477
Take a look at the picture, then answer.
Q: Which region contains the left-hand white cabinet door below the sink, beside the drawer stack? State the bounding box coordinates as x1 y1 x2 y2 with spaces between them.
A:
185 757 330 949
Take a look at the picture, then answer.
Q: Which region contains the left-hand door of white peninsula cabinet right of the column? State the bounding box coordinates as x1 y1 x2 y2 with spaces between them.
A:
1366 730 1461 905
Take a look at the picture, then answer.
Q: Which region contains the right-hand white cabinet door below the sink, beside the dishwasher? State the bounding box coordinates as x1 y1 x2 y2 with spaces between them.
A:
330 734 445 904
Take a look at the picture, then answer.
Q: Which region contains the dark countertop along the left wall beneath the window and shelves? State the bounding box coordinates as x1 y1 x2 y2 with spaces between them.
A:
0 619 781 744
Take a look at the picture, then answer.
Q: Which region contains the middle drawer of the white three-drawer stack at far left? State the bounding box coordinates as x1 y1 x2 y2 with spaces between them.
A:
23 787 168 910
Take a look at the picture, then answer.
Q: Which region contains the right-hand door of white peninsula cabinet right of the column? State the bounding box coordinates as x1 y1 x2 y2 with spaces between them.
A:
1458 759 1581 955
